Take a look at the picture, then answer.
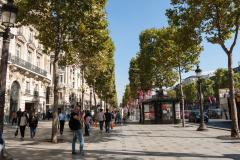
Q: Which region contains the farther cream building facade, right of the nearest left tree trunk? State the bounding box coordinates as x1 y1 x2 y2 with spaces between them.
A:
55 65 100 110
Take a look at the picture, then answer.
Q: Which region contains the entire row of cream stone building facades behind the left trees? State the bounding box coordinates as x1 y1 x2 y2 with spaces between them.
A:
0 22 104 121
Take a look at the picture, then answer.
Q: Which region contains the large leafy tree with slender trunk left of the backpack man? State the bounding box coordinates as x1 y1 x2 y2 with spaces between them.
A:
16 0 111 143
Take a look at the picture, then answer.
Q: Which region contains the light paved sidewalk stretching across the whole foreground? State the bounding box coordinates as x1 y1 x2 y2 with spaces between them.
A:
3 122 240 160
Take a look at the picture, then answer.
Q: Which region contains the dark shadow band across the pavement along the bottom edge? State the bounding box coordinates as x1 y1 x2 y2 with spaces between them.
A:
6 147 240 160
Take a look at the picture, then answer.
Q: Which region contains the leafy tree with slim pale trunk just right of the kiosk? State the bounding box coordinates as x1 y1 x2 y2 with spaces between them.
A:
147 27 201 126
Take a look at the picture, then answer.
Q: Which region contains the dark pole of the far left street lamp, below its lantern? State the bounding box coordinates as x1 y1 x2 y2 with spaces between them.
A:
0 28 10 138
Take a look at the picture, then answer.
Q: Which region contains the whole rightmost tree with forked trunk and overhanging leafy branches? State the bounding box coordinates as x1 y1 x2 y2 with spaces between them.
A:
167 0 240 137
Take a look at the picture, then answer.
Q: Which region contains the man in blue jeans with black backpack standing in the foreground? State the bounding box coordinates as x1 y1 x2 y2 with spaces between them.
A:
69 106 84 156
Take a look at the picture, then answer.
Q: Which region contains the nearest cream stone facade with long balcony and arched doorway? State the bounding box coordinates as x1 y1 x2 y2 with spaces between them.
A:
0 26 51 119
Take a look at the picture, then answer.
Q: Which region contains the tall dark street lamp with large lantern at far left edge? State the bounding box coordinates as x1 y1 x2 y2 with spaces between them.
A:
0 0 17 138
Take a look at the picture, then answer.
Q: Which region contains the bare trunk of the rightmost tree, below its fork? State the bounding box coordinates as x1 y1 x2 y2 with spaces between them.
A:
228 53 239 137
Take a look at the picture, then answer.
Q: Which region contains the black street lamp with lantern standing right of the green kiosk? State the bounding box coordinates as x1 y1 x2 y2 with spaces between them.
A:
195 65 207 131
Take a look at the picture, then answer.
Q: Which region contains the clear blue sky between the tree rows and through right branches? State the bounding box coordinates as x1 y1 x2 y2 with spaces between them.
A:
107 0 240 102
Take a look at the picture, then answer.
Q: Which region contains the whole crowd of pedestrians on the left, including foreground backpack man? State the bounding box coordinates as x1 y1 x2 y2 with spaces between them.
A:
7 106 128 155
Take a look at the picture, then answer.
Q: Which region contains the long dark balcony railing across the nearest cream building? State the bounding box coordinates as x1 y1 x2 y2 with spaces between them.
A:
9 55 47 77
